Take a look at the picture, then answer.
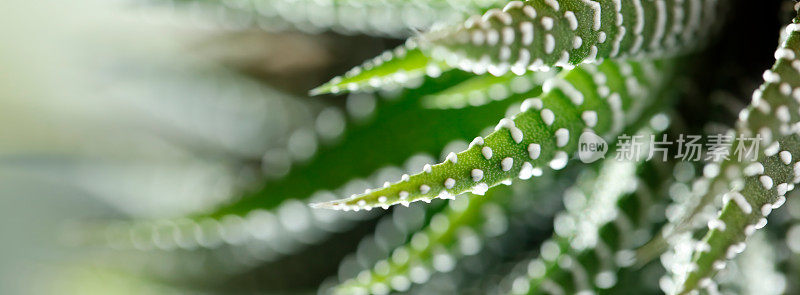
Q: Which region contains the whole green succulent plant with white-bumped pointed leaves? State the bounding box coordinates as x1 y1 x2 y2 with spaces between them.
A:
57 0 800 294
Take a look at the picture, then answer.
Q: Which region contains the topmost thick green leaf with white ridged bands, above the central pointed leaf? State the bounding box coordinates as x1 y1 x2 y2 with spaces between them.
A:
420 0 717 76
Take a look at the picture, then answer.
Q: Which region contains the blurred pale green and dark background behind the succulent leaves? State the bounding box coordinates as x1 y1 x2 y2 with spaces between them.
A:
0 0 800 294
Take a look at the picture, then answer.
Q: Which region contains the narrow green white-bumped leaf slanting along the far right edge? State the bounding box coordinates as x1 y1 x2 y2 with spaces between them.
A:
670 11 800 293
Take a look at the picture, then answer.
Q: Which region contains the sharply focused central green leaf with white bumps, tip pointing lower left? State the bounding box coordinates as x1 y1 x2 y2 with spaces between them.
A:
315 61 674 210
